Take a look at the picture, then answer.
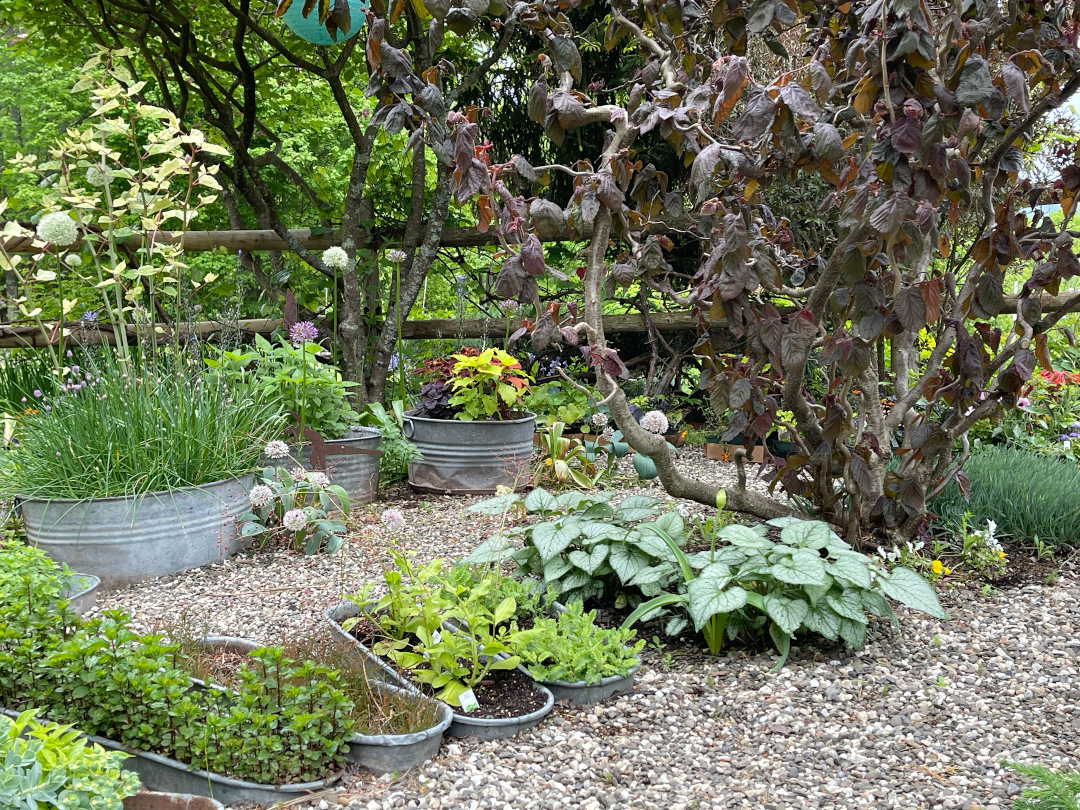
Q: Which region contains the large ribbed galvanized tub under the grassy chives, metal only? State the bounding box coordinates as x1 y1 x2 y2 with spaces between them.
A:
19 475 253 588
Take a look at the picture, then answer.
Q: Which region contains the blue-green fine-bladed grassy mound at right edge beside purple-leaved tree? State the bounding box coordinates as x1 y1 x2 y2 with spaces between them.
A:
929 445 1080 548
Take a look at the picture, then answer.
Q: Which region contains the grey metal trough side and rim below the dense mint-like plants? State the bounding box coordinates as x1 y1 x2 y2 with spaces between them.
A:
87 737 341 807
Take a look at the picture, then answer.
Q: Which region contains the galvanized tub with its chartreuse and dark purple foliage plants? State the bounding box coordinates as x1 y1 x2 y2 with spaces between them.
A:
404 348 536 495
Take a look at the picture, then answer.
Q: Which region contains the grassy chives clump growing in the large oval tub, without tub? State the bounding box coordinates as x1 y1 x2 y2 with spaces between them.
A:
0 351 280 500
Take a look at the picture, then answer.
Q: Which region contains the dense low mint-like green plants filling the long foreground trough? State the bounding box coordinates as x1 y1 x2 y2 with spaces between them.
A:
0 550 353 784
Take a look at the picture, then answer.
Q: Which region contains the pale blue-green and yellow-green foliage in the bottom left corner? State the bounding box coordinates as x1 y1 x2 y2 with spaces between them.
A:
0 710 139 810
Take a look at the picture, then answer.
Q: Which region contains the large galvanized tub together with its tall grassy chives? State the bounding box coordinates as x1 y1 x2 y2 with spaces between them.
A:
0 352 278 586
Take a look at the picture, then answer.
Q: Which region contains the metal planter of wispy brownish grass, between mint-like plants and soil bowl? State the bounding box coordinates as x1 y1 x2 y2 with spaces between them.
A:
195 630 454 774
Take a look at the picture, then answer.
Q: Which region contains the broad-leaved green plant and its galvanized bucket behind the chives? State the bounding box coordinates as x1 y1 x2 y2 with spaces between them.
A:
206 321 382 504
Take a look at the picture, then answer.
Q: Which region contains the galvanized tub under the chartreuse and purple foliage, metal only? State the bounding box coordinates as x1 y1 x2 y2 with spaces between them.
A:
403 410 536 495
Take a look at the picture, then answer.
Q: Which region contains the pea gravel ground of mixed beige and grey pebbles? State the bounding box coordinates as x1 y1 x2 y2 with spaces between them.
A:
98 450 1080 810
